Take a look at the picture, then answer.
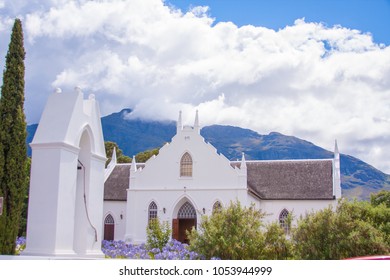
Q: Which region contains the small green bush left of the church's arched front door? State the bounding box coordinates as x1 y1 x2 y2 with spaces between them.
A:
146 218 172 251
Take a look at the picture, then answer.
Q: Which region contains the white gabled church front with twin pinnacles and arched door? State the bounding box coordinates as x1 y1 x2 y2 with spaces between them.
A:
125 110 251 243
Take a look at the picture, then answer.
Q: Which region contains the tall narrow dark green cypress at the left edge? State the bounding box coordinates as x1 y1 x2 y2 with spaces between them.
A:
0 19 27 255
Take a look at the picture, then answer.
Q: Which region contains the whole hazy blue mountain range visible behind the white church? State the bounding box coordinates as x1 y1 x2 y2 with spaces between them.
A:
27 109 390 200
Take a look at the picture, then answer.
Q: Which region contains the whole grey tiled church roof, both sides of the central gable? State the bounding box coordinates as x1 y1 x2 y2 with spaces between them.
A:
104 160 334 201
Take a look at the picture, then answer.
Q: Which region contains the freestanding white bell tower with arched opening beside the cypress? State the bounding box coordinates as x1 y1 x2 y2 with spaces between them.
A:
23 88 106 257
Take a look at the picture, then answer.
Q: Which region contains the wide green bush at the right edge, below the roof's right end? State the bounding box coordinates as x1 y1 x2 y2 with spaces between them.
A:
293 200 390 260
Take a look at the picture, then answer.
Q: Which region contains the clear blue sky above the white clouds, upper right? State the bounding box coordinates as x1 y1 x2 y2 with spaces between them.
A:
166 0 390 45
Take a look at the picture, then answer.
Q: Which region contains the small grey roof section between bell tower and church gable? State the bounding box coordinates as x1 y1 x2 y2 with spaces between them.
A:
104 164 131 201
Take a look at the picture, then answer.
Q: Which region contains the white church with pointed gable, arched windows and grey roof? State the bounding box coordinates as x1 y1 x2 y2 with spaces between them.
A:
103 112 341 243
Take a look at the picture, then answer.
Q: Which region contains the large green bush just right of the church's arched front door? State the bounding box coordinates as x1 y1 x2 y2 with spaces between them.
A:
189 201 291 260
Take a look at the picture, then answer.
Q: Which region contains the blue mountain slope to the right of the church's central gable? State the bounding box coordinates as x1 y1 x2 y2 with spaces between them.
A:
202 125 390 199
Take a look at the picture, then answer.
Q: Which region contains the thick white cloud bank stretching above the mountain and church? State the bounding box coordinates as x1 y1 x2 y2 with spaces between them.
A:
0 0 390 172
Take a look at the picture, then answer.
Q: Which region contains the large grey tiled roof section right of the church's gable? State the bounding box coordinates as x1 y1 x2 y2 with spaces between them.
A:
245 160 333 200
